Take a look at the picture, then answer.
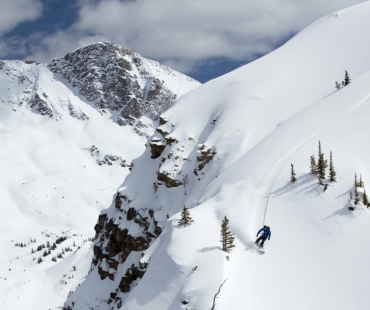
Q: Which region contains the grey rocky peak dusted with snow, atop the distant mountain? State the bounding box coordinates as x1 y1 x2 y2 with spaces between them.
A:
49 42 200 125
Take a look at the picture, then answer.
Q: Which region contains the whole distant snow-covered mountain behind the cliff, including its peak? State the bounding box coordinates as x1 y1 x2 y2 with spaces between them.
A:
0 43 199 309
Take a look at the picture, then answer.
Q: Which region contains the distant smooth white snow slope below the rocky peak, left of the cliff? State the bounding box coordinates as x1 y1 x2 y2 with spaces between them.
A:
0 63 145 309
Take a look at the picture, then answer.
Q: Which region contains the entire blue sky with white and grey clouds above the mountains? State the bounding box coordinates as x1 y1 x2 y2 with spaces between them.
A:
0 0 364 82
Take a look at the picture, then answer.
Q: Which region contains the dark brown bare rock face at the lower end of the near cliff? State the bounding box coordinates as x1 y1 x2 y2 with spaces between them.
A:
85 193 162 309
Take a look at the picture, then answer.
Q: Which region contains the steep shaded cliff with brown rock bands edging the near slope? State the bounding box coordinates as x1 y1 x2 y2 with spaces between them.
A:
64 116 218 310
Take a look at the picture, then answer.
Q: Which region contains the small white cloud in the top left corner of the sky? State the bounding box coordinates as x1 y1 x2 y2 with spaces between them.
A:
0 0 43 35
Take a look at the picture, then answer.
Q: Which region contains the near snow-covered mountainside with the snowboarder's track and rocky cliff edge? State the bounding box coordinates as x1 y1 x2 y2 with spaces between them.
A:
65 2 370 310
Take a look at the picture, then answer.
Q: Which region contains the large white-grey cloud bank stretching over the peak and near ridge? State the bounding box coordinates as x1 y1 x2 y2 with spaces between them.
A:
2 0 363 72
